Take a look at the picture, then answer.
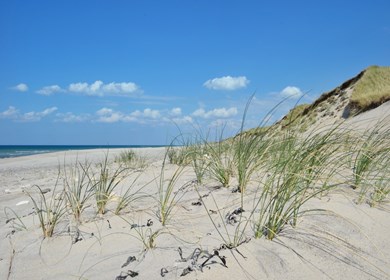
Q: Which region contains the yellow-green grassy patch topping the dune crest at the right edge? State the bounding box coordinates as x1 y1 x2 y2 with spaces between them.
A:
350 66 390 113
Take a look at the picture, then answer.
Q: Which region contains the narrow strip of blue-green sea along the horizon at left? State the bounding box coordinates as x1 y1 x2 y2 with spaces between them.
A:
0 145 164 158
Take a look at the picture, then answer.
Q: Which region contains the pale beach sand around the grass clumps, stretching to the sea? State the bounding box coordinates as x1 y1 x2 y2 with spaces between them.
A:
0 141 390 279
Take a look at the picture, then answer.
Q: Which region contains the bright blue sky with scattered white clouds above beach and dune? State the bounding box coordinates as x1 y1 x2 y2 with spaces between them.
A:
0 0 390 145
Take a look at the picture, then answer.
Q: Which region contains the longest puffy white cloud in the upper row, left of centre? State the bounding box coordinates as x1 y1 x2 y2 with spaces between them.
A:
68 81 139 96
